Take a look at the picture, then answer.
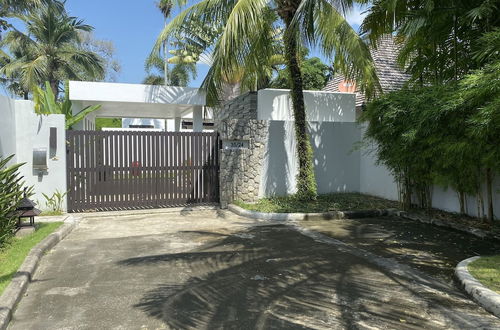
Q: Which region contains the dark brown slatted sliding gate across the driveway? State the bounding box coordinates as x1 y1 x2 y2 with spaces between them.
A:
67 131 219 212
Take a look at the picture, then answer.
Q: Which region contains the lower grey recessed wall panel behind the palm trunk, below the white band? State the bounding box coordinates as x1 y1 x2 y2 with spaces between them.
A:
259 121 360 198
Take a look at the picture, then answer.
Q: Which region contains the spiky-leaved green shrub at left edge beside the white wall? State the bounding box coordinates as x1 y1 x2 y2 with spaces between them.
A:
0 156 31 247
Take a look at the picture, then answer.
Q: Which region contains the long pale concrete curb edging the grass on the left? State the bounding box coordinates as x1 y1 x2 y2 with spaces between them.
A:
0 215 79 330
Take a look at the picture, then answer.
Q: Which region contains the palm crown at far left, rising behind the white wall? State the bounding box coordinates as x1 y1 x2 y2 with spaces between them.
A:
0 2 104 98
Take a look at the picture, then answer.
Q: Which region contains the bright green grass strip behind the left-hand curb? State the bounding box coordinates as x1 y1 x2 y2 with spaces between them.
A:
0 222 62 295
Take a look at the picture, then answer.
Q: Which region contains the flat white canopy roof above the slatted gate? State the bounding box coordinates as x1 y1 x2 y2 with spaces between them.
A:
69 81 206 130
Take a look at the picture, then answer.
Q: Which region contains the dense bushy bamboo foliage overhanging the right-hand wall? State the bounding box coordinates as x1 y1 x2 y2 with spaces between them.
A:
360 61 500 222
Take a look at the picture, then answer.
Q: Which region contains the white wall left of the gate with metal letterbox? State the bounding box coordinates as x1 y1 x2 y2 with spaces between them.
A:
0 95 67 210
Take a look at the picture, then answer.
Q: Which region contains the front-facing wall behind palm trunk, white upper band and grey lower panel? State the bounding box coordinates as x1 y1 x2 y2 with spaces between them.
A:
257 89 360 197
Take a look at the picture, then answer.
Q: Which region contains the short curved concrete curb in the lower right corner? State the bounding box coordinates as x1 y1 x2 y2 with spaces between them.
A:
455 257 500 317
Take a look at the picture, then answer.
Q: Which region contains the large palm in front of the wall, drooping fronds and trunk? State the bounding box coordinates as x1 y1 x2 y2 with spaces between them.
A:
157 0 379 200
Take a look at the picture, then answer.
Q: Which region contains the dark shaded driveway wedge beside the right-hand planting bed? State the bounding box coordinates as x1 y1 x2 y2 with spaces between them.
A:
300 217 500 283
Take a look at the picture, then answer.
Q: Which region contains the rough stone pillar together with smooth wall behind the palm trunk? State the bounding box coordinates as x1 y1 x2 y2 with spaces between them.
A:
215 90 360 206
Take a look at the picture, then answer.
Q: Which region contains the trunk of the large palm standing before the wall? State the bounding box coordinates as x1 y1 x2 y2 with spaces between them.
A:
283 11 318 200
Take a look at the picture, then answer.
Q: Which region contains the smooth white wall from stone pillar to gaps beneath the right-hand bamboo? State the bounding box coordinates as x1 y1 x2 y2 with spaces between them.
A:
257 89 500 218
